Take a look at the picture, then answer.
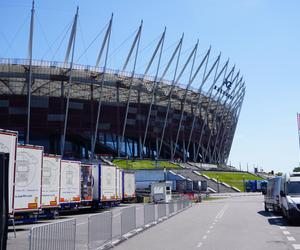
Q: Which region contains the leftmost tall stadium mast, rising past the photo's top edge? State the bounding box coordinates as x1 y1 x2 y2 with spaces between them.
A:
26 1 35 144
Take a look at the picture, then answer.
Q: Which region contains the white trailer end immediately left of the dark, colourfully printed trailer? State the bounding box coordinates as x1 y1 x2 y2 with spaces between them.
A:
60 160 81 207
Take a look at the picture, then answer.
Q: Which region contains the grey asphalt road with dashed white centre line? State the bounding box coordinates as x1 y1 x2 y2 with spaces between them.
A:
114 195 300 250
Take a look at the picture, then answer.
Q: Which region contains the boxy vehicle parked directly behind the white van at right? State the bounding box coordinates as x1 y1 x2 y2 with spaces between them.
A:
264 176 282 212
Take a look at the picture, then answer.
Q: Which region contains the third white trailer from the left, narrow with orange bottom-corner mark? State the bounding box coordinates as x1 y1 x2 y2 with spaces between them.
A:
42 155 61 208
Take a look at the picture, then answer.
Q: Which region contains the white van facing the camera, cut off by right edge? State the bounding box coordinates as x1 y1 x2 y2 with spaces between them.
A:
280 173 300 221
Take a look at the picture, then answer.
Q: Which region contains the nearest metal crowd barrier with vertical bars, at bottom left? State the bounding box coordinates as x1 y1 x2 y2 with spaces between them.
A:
29 219 76 250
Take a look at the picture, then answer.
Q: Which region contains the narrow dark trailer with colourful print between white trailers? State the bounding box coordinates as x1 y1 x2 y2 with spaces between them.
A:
80 164 93 205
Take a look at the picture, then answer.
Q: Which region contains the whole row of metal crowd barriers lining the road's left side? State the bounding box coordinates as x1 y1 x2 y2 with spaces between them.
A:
29 200 191 250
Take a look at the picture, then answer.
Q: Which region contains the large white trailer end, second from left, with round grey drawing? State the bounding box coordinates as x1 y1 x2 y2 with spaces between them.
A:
13 145 44 212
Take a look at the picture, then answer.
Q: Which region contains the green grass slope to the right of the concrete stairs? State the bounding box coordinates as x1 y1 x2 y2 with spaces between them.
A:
202 171 263 191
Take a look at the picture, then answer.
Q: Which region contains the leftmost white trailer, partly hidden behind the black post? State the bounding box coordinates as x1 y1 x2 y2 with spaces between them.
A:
0 129 18 214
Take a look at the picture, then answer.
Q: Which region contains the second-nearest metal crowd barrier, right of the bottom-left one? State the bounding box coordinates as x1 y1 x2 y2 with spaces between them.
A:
88 211 113 249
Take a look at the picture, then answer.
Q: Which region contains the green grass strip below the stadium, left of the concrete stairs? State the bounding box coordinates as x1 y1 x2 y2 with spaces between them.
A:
113 159 179 170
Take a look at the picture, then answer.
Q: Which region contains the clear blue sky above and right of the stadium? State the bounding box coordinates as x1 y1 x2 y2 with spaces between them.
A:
0 0 300 172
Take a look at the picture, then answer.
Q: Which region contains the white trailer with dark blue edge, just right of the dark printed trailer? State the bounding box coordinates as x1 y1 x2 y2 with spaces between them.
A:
93 163 117 204
